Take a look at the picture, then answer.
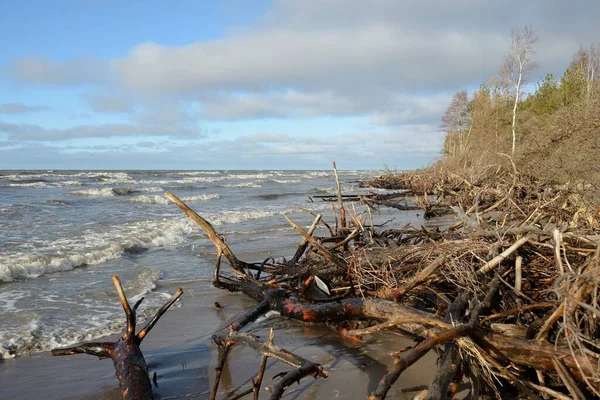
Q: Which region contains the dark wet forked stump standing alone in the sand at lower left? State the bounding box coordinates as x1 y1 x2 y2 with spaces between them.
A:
52 275 183 400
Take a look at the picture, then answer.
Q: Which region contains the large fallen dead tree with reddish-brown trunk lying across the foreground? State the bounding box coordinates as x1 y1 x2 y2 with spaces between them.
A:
166 193 594 399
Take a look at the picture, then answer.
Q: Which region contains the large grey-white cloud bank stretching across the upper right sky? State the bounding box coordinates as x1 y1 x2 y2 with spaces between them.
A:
113 0 600 94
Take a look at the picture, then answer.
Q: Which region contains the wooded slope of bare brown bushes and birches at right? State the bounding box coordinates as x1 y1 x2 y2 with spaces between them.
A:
440 27 600 189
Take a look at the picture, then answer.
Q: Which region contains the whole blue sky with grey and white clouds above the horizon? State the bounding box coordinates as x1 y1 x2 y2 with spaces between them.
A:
0 0 600 170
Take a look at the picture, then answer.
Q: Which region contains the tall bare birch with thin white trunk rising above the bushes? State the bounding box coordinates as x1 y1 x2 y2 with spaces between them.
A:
501 26 538 155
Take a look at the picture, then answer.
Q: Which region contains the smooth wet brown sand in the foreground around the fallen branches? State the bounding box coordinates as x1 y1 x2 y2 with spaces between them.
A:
0 280 435 400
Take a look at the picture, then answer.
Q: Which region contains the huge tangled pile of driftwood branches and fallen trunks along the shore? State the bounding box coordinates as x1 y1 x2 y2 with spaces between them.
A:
162 161 600 399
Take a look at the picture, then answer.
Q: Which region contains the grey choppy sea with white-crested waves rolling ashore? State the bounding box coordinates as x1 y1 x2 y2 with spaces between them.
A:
0 170 418 359
